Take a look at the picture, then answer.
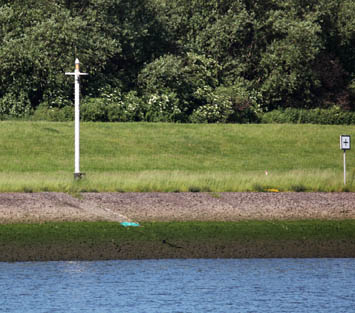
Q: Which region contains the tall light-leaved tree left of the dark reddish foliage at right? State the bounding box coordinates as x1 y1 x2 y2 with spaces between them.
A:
259 7 324 110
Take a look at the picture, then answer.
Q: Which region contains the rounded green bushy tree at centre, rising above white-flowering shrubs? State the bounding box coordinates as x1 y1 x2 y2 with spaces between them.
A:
138 53 221 118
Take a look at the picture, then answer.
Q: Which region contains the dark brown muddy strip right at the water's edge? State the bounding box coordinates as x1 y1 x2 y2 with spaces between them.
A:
0 240 355 262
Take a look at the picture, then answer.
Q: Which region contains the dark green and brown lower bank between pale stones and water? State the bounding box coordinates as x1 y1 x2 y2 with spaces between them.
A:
0 220 355 261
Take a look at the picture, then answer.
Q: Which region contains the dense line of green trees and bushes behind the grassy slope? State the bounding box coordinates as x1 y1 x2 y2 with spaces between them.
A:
0 0 355 122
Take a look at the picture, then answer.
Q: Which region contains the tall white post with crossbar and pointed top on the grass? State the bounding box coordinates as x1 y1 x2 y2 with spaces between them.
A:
65 59 88 179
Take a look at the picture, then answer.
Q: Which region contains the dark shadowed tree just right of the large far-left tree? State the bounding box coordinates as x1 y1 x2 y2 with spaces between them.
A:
75 0 174 93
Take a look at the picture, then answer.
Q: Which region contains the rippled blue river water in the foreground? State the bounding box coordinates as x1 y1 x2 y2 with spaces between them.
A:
0 259 355 313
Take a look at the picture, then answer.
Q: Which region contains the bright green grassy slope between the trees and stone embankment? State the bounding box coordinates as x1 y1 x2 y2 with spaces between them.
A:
0 121 355 192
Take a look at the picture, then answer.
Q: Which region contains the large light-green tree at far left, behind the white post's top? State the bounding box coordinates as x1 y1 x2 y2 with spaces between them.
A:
0 0 119 112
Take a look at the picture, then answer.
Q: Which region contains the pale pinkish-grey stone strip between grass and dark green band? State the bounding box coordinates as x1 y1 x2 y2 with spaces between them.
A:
0 192 355 223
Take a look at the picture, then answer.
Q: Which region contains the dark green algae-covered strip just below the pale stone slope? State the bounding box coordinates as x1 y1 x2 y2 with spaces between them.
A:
4 220 355 241
